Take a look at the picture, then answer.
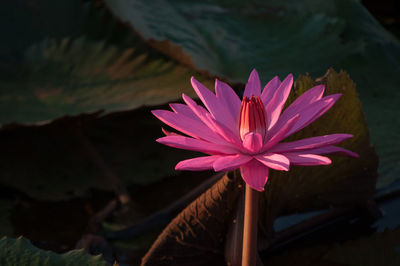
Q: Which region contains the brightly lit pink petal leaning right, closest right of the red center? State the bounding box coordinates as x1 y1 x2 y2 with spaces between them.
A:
265 74 293 129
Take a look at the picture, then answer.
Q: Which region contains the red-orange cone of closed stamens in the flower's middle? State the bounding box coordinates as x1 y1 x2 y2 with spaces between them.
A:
238 95 266 140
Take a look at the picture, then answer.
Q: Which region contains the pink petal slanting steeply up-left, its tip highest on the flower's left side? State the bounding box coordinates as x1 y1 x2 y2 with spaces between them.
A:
191 77 236 128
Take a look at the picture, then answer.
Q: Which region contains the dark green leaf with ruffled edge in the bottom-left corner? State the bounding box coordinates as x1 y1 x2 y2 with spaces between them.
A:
0 237 107 266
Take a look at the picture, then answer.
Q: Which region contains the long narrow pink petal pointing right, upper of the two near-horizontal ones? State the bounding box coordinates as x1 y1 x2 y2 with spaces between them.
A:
271 134 353 152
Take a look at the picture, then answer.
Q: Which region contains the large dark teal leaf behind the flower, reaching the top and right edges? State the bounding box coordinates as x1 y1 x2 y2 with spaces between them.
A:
105 0 400 191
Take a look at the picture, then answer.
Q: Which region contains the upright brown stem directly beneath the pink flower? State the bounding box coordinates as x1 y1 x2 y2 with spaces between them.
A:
242 184 258 266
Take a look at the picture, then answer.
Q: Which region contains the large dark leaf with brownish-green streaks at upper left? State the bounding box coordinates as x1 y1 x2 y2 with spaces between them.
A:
0 0 214 126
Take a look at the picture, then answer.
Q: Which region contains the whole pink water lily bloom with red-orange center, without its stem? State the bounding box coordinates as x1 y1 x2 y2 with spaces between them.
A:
152 70 358 191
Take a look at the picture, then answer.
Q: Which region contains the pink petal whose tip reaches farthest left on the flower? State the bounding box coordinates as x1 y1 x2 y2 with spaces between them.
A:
151 110 226 143
